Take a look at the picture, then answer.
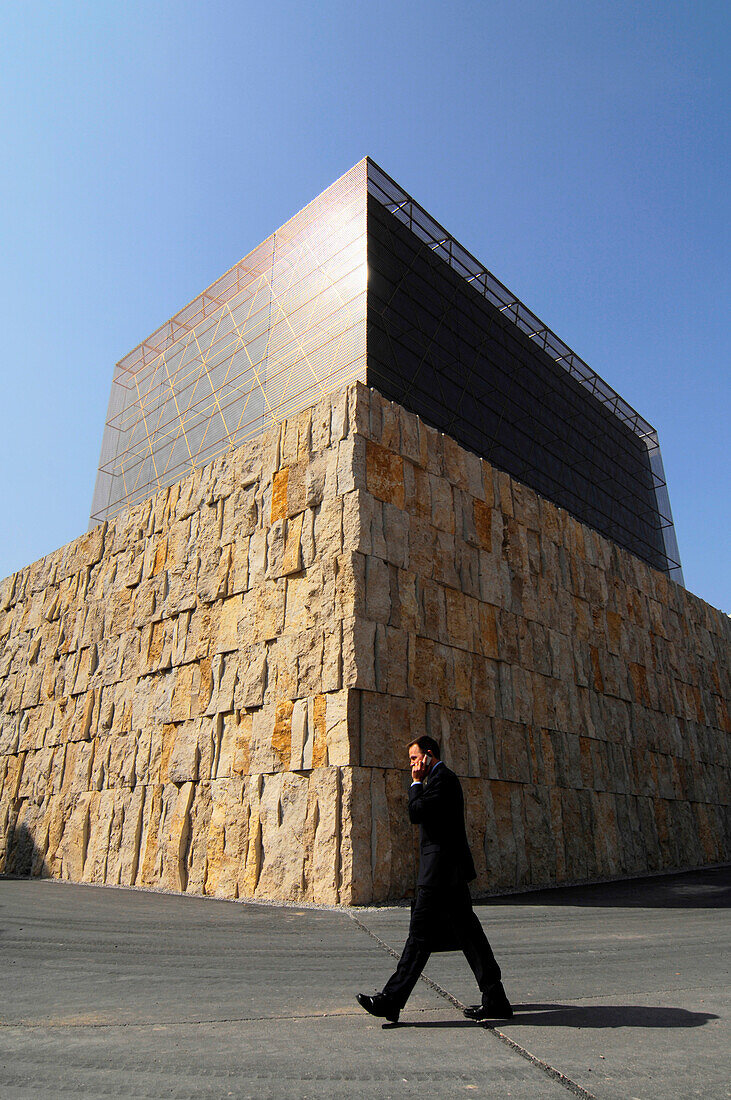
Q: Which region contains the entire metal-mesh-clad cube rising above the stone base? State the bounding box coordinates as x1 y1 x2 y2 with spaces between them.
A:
91 157 682 582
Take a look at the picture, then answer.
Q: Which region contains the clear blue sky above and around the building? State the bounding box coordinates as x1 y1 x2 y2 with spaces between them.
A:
0 0 731 612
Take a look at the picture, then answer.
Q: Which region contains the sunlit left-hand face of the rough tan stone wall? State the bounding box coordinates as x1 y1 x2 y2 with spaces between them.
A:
0 392 357 903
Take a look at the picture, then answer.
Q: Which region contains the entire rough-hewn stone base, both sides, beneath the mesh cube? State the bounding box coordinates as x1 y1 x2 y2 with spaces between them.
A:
0 384 731 904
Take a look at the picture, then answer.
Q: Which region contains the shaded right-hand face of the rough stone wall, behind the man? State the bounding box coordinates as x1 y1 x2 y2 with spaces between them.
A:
345 392 731 901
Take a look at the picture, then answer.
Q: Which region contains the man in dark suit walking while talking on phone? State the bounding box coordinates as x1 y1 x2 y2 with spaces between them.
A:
356 736 512 1023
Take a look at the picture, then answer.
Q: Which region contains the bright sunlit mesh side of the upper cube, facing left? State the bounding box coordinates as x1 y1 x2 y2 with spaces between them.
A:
91 161 367 526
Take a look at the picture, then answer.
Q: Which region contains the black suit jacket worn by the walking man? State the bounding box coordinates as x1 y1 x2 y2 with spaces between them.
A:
409 762 477 889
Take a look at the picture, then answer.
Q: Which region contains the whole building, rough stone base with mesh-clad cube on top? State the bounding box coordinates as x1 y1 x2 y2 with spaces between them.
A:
0 160 731 905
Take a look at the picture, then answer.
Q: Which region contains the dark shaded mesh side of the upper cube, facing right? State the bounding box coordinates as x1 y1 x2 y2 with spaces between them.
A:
367 164 682 582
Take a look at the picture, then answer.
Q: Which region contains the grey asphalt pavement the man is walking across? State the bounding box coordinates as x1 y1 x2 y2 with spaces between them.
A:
0 869 731 1100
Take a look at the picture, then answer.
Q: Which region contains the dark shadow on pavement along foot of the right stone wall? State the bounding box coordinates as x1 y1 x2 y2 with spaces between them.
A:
475 867 731 909
